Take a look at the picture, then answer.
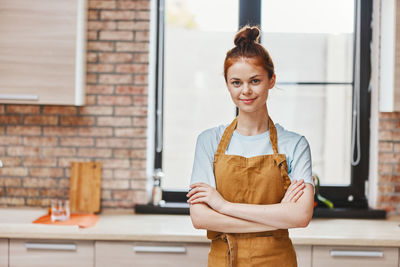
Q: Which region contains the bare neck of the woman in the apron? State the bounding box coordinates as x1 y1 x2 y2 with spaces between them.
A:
236 106 269 136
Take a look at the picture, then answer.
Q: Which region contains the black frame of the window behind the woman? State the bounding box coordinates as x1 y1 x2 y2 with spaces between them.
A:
154 0 372 209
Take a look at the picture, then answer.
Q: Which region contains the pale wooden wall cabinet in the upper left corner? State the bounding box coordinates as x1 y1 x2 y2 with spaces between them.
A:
0 0 87 106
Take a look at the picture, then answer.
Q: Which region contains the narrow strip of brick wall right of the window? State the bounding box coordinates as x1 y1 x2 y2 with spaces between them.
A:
377 112 400 214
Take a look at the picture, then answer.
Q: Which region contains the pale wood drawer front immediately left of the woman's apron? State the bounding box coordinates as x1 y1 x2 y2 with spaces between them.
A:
95 241 209 267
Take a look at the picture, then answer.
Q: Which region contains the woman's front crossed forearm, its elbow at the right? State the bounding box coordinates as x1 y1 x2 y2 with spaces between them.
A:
220 185 314 229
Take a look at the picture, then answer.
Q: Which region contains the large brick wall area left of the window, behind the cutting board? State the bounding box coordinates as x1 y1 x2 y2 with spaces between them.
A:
0 0 150 208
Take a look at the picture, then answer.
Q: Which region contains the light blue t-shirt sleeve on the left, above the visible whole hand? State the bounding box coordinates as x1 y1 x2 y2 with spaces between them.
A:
190 130 216 188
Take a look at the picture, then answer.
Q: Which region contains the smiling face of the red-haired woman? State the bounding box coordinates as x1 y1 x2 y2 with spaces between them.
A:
227 58 275 113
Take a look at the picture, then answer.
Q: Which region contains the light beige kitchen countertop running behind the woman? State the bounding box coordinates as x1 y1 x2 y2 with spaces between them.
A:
0 208 400 247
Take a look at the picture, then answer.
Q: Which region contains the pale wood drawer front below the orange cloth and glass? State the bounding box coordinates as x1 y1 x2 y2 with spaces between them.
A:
10 239 94 267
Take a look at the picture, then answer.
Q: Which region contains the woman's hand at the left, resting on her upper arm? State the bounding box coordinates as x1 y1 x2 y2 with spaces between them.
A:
186 183 228 212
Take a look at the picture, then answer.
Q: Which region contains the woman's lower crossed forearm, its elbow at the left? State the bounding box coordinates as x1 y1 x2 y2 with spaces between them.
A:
190 204 277 233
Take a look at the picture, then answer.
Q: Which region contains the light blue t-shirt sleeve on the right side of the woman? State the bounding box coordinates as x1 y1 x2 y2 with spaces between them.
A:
289 136 314 189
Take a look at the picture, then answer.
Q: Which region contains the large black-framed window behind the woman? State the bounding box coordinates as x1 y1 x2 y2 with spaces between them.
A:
155 0 372 208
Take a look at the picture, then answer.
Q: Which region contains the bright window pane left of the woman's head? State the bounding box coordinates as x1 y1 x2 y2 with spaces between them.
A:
162 0 239 189
